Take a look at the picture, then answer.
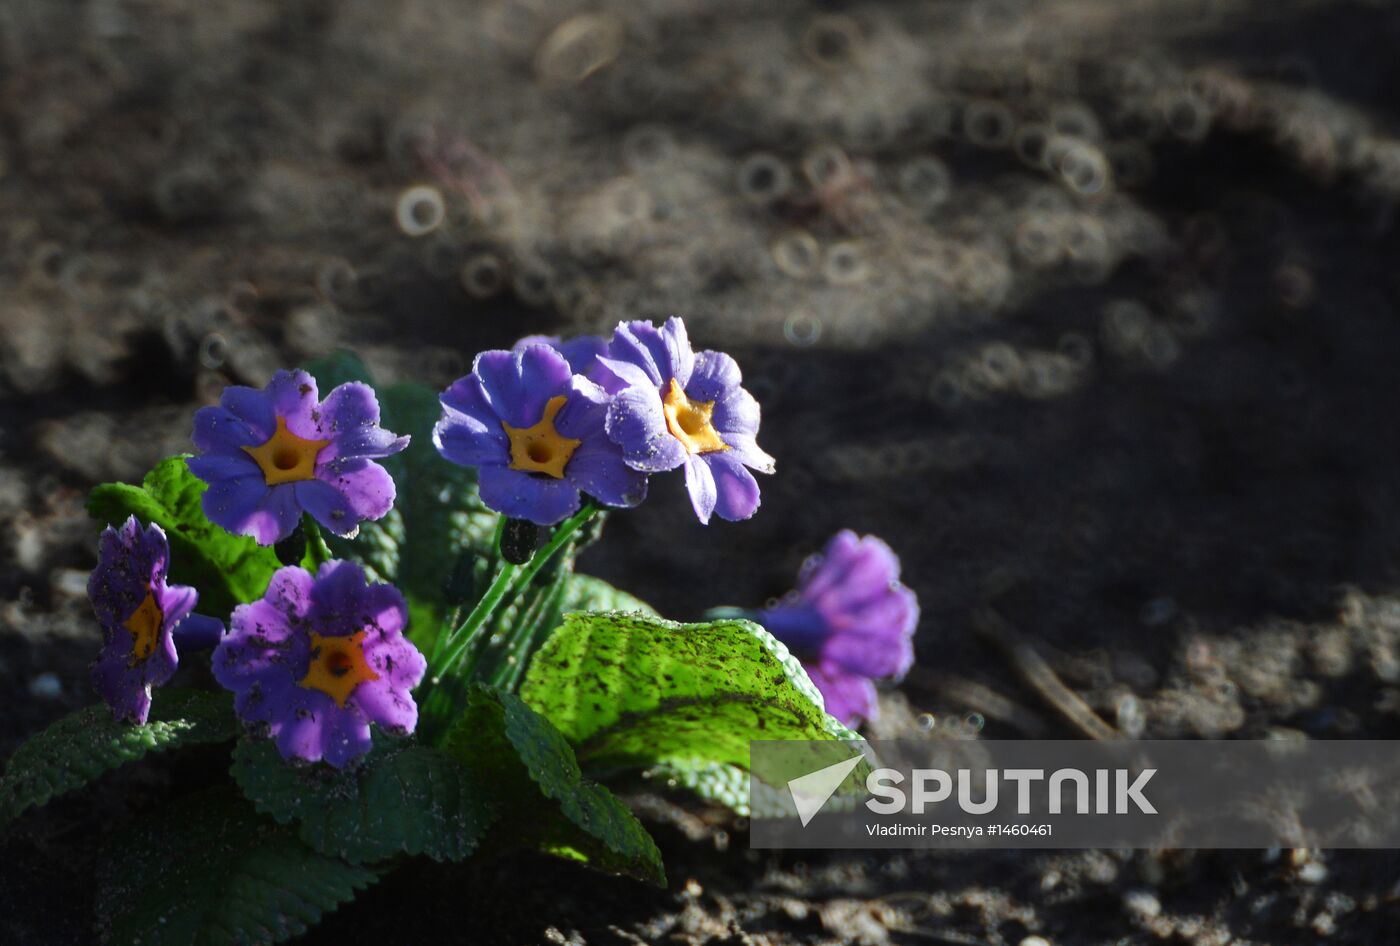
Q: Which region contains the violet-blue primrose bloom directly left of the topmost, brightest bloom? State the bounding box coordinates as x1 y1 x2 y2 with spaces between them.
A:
433 344 647 526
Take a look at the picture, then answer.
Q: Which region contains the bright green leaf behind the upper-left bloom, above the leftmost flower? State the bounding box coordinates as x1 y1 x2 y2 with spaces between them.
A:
87 456 281 614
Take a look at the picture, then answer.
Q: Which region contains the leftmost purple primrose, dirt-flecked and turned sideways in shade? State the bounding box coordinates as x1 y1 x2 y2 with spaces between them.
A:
88 516 223 723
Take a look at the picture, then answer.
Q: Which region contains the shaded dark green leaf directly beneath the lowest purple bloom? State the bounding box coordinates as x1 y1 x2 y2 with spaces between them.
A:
232 739 494 863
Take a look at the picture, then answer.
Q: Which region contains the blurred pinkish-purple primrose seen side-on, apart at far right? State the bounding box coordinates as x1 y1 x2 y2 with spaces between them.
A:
756 529 918 725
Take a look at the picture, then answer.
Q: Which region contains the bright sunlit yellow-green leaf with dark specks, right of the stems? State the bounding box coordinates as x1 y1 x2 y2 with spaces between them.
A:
521 612 855 768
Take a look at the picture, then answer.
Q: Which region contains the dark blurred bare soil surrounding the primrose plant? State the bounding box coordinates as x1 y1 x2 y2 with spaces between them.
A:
0 0 1400 946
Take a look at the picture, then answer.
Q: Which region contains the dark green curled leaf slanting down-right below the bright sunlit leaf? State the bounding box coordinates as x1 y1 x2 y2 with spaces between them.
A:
444 686 665 886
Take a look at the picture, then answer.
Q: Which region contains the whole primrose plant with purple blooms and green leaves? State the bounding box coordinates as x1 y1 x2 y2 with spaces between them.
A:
0 319 917 946
